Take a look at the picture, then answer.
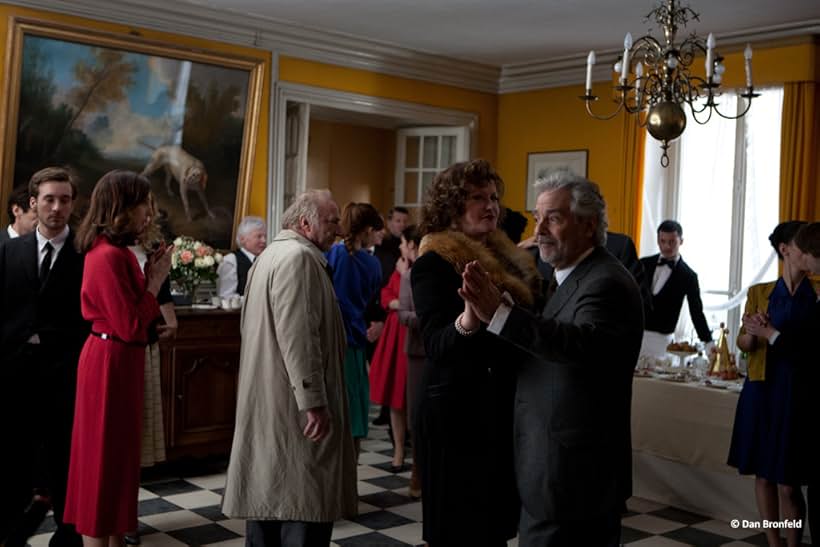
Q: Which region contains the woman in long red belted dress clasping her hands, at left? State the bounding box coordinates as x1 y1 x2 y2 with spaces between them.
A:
64 170 173 547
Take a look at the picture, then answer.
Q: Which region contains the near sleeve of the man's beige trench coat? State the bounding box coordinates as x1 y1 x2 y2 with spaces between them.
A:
270 252 332 410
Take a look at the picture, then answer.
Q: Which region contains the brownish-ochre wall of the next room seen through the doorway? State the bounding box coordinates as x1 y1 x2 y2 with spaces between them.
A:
307 120 396 213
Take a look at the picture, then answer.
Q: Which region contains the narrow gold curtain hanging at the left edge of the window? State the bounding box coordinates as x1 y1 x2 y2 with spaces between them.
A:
622 114 646 249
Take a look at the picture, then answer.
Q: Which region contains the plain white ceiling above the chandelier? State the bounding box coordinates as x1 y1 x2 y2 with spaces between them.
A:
183 0 820 66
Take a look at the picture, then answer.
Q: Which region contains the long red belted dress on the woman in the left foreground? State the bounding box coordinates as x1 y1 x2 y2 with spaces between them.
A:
63 236 160 537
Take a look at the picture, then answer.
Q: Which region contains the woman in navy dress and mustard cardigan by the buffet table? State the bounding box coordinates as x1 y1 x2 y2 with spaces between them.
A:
728 221 817 547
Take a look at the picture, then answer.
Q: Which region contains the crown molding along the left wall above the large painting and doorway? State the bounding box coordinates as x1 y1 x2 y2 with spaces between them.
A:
5 0 501 93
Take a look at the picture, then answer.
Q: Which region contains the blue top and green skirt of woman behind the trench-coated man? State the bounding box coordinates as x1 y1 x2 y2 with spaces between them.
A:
326 243 382 438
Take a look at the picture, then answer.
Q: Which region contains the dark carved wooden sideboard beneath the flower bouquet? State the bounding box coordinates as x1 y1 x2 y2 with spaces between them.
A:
161 307 240 461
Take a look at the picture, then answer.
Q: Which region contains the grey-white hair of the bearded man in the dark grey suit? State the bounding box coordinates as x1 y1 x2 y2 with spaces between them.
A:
534 168 609 246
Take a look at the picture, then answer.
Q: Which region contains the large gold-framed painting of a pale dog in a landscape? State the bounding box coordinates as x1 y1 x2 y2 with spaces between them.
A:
0 19 265 248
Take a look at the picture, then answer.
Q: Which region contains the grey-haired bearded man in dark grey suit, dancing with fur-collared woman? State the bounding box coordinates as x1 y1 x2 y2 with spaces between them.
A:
460 171 643 547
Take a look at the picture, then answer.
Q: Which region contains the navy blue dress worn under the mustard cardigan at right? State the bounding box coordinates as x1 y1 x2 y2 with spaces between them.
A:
728 278 817 485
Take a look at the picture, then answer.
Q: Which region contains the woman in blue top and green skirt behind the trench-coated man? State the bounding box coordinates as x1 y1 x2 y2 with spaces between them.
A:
327 203 384 454
